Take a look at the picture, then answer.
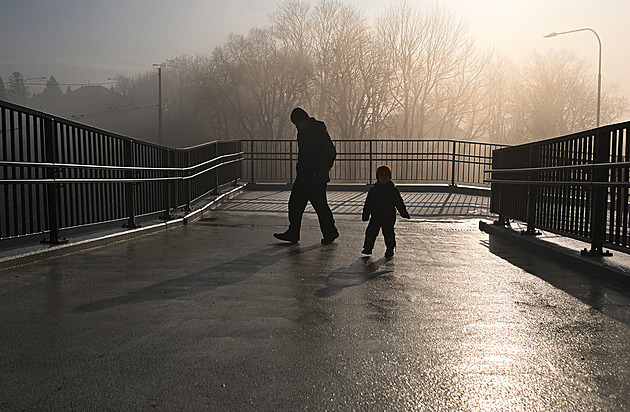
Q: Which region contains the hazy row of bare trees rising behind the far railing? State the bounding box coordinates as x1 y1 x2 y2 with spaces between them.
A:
2 0 627 144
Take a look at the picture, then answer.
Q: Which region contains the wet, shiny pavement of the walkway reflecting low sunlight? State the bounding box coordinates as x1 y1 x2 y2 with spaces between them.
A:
0 192 630 411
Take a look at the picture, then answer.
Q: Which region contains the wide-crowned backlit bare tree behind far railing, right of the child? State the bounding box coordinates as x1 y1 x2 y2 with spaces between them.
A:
376 1 478 139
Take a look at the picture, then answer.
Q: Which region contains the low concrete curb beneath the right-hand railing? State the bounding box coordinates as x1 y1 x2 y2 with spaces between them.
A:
479 220 630 287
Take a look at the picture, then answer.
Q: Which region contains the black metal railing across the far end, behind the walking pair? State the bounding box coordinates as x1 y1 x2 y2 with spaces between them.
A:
243 139 506 187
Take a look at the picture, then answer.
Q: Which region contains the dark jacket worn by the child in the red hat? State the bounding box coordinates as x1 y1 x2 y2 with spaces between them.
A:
363 180 409 222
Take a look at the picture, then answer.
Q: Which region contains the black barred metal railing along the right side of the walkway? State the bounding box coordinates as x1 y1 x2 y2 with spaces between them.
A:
487 122 630 255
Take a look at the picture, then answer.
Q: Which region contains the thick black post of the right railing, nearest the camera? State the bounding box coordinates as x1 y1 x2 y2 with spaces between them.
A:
582 130 612 256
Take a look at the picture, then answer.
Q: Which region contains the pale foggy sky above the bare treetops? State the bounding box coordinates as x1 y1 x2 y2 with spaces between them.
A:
0 0 630 110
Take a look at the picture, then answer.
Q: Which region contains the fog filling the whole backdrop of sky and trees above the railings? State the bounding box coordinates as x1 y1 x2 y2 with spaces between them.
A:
0 0 630 146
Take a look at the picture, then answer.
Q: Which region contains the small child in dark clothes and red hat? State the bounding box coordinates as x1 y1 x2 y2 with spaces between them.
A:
361 165 410 258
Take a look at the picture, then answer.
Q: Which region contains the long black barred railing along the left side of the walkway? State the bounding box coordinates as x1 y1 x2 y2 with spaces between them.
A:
0 100 243 243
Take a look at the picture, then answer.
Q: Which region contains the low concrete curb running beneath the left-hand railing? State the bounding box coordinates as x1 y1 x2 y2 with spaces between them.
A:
0 186 243 270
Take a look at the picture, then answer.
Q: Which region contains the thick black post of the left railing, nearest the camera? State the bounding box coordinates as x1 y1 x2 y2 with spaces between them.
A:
42 117 67 244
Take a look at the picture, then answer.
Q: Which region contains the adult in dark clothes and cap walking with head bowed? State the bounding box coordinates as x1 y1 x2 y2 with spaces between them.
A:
274 107 339 244
